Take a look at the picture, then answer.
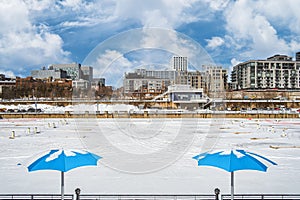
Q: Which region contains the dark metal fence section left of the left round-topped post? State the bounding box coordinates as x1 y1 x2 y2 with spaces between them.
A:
0 194 74 200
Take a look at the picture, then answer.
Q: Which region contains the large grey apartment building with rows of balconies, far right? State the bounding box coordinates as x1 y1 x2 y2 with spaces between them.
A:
231 54 300 90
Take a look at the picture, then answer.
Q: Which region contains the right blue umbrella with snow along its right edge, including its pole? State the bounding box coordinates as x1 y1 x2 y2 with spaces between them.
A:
193 150 277 199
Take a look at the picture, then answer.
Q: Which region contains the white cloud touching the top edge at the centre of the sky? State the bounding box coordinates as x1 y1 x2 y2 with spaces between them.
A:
114 0 206 28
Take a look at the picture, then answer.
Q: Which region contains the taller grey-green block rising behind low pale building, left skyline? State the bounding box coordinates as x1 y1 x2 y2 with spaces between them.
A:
48 63 82 80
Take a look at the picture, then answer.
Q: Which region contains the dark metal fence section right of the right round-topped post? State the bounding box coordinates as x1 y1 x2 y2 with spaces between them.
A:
221 194 300 200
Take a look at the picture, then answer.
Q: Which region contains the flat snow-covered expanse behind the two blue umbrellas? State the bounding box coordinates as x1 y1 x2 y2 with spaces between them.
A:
0 116 300 194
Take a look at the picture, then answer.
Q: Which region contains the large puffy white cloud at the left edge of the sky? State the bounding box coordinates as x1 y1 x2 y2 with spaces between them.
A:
0 0 69 71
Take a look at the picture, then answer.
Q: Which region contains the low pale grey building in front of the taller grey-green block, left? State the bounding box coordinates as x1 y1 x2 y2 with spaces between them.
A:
31 67 67 79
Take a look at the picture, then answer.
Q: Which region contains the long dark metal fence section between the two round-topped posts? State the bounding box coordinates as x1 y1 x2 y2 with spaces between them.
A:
80 194 215 200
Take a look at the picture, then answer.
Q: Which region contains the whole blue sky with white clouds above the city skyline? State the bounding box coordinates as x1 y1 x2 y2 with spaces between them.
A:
0 0 300 84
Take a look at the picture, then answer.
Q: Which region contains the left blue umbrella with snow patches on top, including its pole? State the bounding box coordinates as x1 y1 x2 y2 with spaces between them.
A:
27 149 101 199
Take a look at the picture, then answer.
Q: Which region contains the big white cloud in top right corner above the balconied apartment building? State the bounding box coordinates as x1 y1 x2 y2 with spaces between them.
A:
224 0 300 58
